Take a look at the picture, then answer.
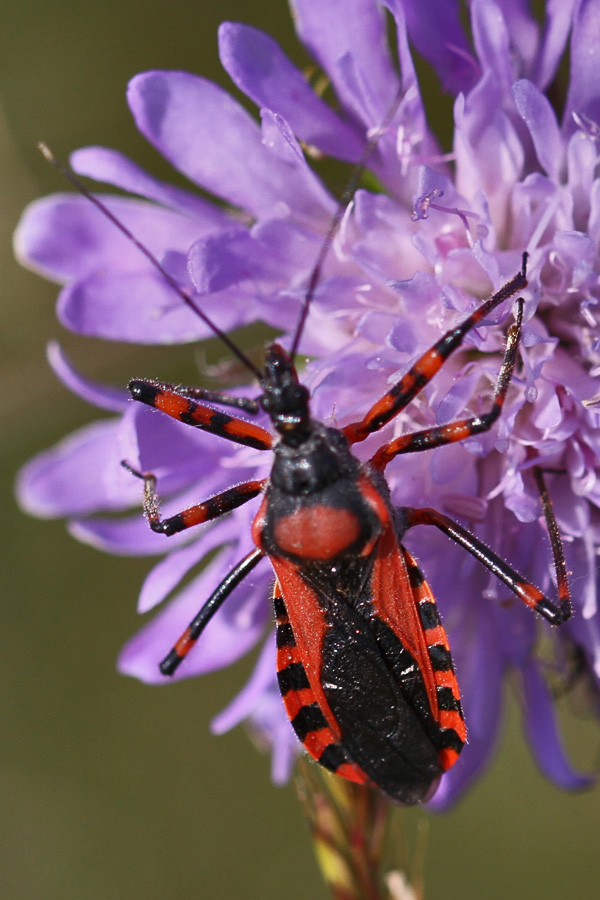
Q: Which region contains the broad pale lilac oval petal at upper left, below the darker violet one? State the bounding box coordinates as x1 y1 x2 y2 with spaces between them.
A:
128 72 332 221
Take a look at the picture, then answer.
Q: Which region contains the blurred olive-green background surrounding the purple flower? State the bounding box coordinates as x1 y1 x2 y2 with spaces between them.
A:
0 0 600 900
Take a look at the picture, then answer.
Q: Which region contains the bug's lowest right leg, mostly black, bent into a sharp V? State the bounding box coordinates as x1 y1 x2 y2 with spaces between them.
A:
400 502 571 625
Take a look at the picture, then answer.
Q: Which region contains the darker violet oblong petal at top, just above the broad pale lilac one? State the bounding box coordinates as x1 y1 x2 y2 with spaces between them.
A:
219 22 365 162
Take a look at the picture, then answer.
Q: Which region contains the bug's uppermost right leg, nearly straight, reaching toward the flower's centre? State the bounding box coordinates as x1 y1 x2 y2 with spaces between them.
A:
342 253 527 444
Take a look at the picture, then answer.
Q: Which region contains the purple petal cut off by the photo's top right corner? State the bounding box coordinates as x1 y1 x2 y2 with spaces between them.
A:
564 0 600 135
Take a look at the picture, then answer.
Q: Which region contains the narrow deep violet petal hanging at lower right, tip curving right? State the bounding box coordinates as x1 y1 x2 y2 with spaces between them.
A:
521 661 595 790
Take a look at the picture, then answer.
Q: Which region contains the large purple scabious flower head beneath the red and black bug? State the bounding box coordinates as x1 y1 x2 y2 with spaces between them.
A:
16 0 600 806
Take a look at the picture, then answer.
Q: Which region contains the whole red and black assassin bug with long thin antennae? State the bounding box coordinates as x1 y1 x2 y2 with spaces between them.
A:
39 102 571 804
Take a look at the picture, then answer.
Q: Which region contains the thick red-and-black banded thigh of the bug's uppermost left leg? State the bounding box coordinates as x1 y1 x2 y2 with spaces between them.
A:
128 380 273 450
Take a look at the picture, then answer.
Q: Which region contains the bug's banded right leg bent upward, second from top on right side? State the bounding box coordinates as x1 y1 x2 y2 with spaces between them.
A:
370 298 523 472
